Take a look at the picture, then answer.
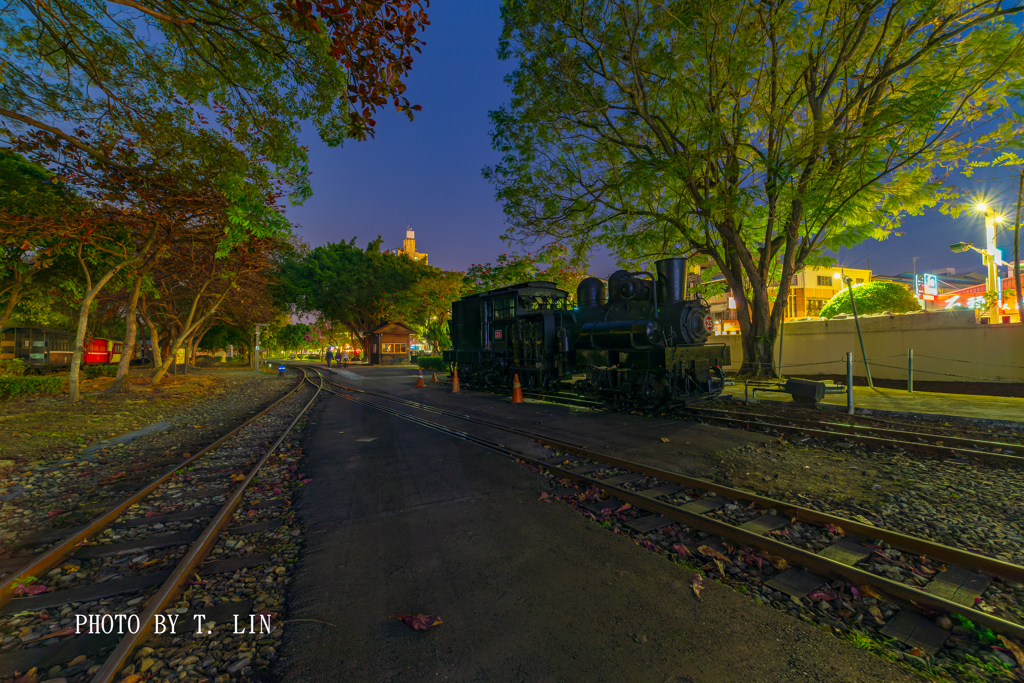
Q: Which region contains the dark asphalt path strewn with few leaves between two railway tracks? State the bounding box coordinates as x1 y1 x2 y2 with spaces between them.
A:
275 370 920 683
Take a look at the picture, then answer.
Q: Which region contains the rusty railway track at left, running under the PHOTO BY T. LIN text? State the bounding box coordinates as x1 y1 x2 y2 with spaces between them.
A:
0 372 323 683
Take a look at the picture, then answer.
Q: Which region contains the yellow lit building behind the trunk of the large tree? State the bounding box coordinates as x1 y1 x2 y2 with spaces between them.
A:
708 265 871 333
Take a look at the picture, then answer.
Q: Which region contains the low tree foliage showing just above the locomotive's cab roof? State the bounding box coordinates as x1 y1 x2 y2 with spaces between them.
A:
466 244 587 299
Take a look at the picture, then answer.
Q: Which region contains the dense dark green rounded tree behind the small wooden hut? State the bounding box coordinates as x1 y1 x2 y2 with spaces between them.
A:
280 237 437 351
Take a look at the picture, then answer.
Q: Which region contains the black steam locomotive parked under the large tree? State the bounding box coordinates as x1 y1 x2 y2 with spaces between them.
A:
444 258 730 410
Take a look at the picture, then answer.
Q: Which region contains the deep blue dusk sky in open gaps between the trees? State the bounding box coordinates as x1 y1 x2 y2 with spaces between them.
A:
288 0 1017 276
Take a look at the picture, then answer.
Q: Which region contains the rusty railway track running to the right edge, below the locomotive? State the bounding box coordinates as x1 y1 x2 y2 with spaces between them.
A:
311 368 1024 654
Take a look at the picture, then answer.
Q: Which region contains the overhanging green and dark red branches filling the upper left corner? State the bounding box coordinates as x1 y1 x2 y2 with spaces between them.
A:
0 0 429 189
